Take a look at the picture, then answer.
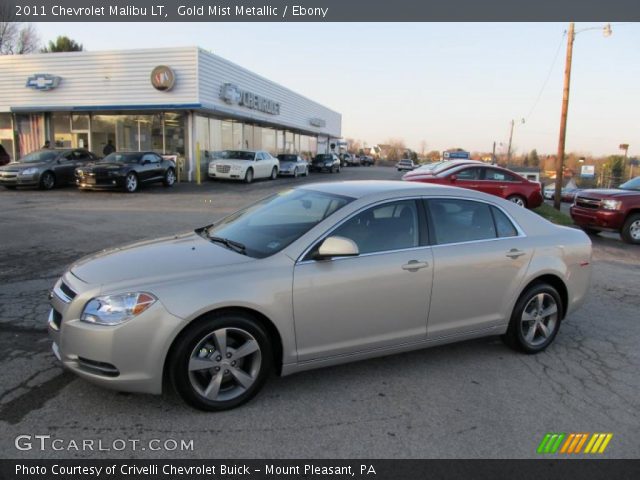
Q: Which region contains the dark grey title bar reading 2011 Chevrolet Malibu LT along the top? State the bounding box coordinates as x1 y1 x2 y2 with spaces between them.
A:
0 0 640 22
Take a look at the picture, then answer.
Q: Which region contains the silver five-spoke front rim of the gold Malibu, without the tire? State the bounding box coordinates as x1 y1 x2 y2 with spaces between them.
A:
188 328 262 402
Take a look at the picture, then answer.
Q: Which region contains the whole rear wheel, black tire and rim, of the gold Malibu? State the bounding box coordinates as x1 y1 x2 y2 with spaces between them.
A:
502 283 564 354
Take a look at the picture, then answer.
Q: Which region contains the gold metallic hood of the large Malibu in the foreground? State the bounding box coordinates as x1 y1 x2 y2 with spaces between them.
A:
70 232 253 285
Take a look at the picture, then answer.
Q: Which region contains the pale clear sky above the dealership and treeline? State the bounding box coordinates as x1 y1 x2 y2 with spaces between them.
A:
36 19 640 155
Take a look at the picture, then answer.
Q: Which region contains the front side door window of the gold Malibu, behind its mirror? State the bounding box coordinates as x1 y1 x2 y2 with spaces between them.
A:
331 200 420 254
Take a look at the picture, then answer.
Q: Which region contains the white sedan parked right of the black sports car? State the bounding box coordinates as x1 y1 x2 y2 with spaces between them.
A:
209 150 280 183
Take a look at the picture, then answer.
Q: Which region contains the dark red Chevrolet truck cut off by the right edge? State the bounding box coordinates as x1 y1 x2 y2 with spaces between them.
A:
570 177 640 245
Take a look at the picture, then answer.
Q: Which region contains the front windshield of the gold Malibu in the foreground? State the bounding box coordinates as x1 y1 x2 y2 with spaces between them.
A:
202 189 353 258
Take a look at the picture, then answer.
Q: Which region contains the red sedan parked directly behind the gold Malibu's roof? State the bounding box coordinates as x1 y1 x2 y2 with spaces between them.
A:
403 162 543 208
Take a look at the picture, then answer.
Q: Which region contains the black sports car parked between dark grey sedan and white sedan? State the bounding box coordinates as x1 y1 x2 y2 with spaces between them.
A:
76 152 176 193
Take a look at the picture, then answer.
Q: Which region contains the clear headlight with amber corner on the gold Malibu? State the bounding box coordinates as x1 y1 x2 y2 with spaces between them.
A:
80 292 157 325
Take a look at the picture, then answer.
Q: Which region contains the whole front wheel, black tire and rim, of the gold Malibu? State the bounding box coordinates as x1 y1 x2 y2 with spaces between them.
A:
167 313 273 411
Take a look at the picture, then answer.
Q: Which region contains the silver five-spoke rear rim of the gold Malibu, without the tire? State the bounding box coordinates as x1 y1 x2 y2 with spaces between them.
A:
520 293 558 347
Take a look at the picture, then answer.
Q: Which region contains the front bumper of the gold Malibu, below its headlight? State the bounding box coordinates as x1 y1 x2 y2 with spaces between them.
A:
48 273 182 394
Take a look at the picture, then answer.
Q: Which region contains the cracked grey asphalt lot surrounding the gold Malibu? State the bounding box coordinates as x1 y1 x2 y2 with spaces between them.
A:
0 167 640 459
